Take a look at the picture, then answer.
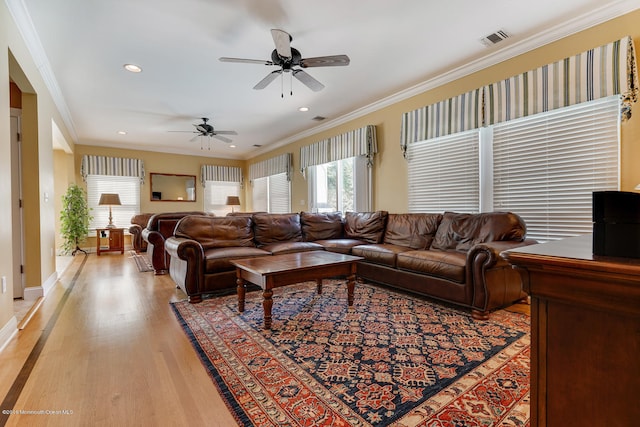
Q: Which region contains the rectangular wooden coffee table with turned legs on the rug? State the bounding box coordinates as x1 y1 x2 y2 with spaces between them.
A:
231 251 363 329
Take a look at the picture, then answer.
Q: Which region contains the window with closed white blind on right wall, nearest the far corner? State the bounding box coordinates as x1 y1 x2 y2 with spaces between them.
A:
252 173 291 213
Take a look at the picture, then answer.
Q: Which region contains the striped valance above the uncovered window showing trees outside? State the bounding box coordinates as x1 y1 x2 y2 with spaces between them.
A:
300 125 378 175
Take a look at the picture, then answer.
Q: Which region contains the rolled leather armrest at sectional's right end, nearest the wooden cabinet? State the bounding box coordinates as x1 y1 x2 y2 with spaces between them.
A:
467 239 537 319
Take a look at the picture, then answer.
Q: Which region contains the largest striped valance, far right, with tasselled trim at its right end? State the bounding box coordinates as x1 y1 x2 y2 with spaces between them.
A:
484 37 638 126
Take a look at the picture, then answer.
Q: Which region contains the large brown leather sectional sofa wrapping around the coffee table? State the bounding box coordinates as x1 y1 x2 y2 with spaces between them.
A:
165 211 536 319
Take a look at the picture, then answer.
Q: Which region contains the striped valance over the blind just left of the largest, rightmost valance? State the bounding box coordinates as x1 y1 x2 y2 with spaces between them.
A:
400 89 482 153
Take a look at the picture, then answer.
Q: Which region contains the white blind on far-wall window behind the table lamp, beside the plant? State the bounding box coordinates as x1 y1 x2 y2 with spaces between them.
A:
86 175 140 229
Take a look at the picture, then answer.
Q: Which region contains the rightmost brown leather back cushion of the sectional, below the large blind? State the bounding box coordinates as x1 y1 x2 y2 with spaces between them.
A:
431 212 527 252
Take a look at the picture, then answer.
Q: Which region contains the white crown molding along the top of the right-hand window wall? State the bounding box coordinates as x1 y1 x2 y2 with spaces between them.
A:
244 0 640 160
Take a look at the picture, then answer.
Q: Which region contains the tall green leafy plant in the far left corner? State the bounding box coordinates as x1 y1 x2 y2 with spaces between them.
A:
60 184 93 255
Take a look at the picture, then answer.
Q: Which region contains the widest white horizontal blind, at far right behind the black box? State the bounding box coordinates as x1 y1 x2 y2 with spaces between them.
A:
493 96 620 241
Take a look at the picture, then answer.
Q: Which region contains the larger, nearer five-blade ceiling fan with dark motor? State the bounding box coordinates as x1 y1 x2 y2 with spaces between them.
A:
219 29 350 96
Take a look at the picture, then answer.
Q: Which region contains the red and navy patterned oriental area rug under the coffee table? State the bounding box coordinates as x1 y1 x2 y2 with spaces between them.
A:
172 280 530 427
